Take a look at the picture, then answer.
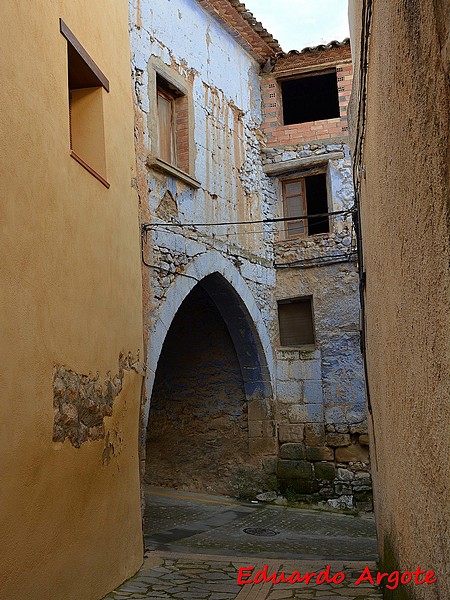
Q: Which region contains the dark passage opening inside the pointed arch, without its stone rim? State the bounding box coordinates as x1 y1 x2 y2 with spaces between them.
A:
146 285 249 493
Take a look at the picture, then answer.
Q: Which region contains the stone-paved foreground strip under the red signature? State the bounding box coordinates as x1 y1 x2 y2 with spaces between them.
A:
100 551 382 600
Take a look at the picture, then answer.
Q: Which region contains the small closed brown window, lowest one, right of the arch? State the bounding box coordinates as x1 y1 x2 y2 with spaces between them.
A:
278 296 314 346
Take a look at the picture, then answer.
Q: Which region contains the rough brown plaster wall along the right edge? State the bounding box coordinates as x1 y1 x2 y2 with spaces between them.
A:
350 0 450 600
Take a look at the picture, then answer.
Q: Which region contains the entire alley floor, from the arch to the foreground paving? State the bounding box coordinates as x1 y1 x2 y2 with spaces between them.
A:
104 487 382 600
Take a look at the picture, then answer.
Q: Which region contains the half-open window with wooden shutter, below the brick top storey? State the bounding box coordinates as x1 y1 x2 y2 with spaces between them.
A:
283 173 330 238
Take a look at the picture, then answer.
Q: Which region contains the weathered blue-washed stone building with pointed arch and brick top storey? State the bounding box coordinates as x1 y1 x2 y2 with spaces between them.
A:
130 0 371 508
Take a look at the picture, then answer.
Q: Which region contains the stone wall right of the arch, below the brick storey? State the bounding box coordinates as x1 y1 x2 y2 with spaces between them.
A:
263 134 372 510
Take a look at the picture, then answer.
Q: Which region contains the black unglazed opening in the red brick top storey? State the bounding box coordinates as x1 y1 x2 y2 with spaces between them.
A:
281 69 340 125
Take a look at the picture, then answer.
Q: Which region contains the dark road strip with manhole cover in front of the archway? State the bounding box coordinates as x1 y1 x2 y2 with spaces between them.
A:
144 487 377 561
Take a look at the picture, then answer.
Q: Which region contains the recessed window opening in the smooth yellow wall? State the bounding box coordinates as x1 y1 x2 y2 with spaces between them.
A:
60 19 109 187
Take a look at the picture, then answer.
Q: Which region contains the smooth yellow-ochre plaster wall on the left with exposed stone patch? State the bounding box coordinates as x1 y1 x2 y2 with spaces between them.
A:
0 0 143 600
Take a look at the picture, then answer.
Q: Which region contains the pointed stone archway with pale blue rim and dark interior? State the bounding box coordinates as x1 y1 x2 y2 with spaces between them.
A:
146 257 276 494
